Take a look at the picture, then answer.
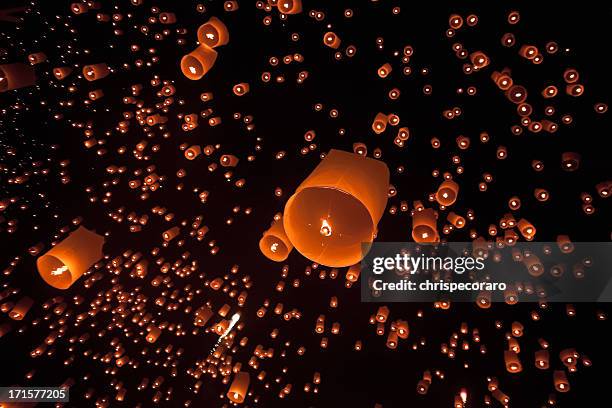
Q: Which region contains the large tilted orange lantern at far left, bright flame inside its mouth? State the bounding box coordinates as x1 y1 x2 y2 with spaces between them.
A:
36 227 104 289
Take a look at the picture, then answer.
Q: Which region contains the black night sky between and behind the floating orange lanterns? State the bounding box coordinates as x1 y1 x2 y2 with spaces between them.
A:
0 1 611 407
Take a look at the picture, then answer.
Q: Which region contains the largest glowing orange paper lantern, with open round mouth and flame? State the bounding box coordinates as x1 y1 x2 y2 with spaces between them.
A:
283 150 389 267
